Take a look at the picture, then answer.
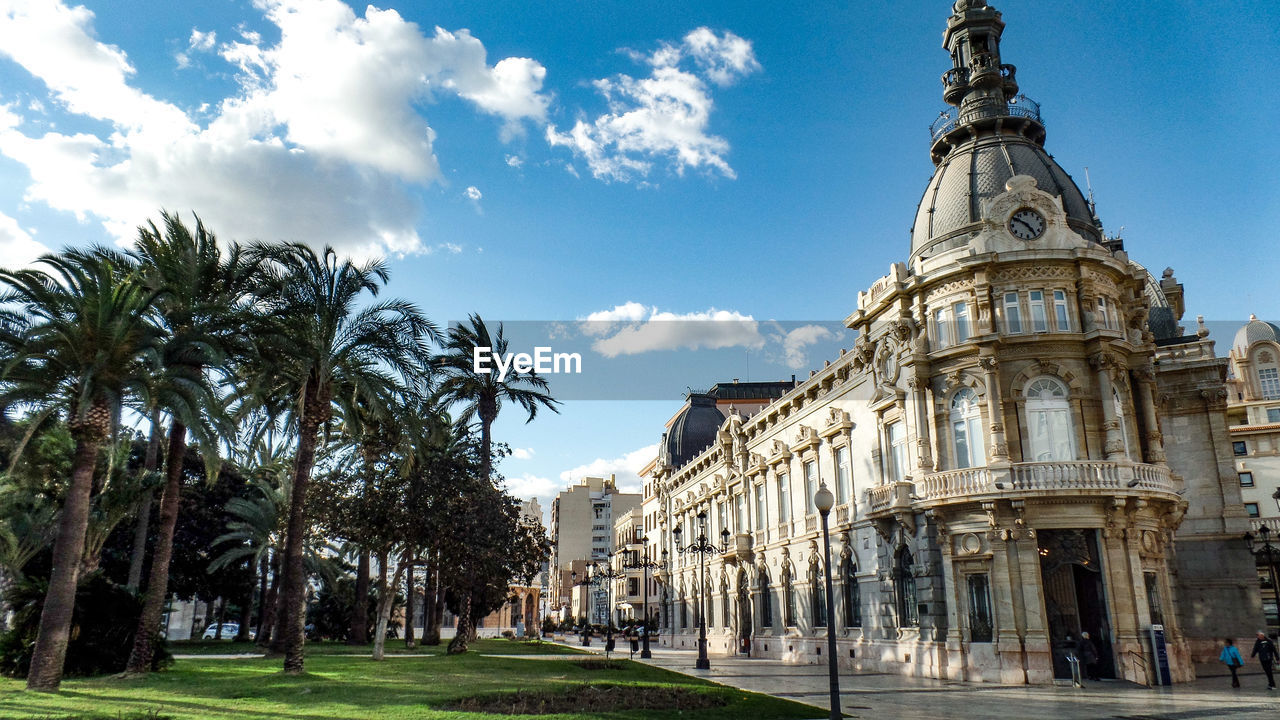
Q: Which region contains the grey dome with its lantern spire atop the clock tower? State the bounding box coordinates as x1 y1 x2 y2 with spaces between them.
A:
911 0 1103 264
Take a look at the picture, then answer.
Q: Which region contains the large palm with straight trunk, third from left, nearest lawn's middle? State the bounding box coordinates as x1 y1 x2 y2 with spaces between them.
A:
247 243 436 674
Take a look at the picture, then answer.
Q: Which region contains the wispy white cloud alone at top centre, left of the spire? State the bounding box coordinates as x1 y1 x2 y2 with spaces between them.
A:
547 27 760 182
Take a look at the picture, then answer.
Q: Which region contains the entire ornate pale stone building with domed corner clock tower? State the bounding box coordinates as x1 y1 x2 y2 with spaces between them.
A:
643 0 1261 683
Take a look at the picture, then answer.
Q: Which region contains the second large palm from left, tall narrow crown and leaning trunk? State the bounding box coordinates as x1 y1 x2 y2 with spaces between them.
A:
125 213 257 673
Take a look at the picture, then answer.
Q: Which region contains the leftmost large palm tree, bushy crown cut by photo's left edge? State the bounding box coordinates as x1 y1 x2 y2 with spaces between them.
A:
0 251 161 691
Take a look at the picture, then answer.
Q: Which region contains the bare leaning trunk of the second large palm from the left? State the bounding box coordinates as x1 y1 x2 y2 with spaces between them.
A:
124 420 187 673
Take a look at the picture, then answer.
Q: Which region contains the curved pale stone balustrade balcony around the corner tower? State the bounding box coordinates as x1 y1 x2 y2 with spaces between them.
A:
867 460 1178 518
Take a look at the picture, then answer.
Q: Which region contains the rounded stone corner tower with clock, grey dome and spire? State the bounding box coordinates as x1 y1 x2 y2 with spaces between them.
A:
846 0 1243 683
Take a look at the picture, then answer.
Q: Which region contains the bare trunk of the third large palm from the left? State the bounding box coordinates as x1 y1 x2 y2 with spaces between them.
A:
280 379 329 675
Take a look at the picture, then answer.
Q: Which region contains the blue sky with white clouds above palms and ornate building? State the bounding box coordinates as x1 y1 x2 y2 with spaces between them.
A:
0 0 1280 512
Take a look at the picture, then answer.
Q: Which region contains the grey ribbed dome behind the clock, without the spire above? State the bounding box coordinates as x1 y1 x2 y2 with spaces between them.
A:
911 133 1102 259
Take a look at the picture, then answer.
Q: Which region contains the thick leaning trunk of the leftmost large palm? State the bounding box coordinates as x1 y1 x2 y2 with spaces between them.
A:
27 427 106 692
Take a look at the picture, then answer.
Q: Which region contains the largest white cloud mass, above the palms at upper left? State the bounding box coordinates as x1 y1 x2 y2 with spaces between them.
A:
0 0 548 255
